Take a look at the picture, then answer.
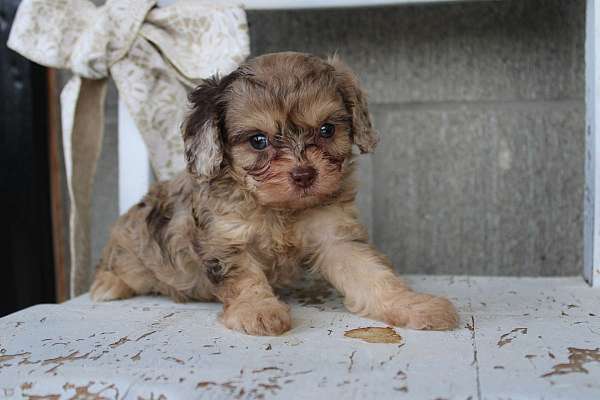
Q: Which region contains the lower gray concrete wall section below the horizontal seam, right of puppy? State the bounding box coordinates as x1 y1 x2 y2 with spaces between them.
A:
373 101 584 275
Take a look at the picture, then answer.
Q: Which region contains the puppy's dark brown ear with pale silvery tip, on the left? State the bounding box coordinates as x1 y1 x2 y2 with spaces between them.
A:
182 73 234 178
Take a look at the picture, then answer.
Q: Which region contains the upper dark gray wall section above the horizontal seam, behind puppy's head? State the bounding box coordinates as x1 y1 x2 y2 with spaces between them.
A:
248 0 585 103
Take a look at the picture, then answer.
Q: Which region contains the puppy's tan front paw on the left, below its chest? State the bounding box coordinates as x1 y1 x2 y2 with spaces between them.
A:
221 298 292 336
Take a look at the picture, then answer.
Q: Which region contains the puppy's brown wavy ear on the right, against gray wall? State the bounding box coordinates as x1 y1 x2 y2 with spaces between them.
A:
327 55 379 153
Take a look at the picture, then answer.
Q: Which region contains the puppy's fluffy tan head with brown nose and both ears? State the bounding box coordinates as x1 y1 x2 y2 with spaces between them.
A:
183 53 377 208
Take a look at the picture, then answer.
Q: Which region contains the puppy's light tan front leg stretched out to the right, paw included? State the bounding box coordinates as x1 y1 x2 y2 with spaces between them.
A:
315 241 458 330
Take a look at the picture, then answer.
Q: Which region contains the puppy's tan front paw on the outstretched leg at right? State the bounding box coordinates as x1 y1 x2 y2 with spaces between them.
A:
384 292 458 331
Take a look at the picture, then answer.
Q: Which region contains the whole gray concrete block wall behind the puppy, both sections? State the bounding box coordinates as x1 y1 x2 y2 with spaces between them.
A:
88 0 585 275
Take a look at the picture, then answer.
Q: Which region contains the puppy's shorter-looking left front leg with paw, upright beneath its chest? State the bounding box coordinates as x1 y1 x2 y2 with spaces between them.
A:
215 256 292 336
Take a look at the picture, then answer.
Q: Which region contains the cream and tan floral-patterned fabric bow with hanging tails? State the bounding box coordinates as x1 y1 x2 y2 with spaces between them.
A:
8 0 249 296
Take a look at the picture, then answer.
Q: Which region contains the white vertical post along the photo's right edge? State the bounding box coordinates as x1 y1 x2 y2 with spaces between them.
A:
583 0 600 287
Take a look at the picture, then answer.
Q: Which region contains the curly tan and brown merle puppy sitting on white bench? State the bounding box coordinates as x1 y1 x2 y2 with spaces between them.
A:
91 52 458 335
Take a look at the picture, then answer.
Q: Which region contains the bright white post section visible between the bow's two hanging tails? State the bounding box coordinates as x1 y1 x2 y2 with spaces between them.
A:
119 100 152 214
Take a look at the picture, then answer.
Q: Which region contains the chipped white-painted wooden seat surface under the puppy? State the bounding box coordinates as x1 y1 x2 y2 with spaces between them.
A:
0 276 600 400
